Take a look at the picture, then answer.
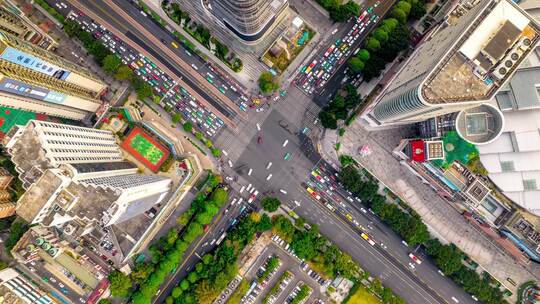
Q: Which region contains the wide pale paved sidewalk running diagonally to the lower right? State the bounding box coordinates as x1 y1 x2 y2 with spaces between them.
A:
319 123 539 293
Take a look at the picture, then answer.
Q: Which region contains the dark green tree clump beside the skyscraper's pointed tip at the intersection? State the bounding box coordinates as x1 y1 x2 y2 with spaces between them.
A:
319 83 363 130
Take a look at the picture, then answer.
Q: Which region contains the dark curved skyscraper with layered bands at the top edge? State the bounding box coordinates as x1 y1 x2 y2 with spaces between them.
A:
209 0 289 44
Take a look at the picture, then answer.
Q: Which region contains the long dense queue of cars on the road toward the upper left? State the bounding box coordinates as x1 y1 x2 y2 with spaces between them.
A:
68 12 232 137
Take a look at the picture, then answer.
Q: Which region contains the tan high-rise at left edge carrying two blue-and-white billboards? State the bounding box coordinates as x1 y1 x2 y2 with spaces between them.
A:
0 31 107 120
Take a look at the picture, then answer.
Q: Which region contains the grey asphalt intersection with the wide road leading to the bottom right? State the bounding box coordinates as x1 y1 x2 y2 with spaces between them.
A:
215 83 474 304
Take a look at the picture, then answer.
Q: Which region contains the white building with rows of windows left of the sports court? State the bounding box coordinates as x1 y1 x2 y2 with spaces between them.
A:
5 120 123 188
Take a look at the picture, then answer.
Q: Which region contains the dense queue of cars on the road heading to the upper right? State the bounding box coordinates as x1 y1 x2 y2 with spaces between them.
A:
295 1 379 94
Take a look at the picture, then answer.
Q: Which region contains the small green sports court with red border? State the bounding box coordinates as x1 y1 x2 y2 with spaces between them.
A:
122 127 170 172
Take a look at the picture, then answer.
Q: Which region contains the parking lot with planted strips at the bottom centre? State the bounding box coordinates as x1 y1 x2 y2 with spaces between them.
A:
242 236 330 304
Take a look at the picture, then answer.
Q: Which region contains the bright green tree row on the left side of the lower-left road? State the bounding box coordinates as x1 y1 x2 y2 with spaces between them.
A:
109 175 228 303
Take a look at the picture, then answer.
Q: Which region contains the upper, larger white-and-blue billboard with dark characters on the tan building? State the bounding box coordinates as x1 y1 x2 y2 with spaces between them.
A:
0 46 70 80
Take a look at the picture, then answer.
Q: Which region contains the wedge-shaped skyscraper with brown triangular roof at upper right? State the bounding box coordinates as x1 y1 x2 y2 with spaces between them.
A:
363 0 540 126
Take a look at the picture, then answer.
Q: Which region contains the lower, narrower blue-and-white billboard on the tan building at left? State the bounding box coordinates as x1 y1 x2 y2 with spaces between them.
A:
0 77 67 104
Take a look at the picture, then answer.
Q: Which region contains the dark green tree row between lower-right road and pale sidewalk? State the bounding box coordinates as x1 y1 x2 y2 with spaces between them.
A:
339 164 506 304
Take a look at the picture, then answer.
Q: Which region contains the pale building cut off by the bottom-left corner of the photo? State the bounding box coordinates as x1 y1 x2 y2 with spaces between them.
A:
0 268 58 304
